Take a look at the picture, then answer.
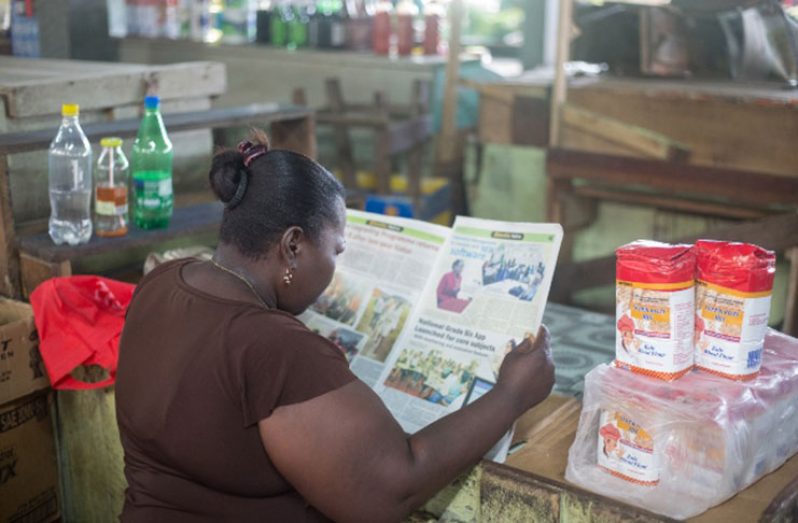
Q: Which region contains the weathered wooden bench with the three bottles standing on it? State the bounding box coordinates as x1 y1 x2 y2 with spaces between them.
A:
0 104 316 298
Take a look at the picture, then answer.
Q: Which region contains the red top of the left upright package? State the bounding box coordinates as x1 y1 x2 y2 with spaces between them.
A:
615 241 695 283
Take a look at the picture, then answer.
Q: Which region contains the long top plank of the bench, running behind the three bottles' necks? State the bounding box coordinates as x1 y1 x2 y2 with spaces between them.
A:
0 104 313 155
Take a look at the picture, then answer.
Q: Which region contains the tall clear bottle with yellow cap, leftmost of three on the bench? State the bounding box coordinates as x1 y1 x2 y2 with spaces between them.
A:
48 104 92 249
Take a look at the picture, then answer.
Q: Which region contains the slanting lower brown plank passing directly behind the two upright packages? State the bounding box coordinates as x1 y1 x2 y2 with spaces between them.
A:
551 213 798 303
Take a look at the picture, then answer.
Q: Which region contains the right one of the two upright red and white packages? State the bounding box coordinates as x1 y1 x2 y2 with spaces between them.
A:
694 240 776 380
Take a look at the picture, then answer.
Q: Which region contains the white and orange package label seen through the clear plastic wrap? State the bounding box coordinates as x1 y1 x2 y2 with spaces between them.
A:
598 410 659 486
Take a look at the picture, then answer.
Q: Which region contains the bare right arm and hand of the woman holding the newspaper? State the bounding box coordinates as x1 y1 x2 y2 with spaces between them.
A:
259 329 554 522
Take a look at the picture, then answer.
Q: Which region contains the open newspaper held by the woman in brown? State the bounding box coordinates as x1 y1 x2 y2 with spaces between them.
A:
301 210 562 461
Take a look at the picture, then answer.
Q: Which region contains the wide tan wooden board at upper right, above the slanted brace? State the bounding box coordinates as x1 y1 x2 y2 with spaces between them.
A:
572 79 798 176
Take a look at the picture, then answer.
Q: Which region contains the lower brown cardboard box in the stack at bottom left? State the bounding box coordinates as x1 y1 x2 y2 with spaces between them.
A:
0 393 59 523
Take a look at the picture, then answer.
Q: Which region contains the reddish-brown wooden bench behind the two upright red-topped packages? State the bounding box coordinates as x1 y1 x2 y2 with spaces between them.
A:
546 149 798 335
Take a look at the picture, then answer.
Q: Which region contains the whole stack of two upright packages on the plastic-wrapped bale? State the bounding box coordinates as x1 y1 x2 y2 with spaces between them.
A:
566 240 798 518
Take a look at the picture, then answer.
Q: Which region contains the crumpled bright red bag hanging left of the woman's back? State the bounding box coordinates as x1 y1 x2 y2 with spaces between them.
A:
30 276 135 389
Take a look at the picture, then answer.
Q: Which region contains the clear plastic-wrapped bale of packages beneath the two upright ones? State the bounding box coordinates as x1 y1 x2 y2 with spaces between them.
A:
565 329 798 519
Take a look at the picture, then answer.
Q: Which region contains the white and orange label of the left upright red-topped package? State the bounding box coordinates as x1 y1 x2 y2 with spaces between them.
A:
615 281 695 379
